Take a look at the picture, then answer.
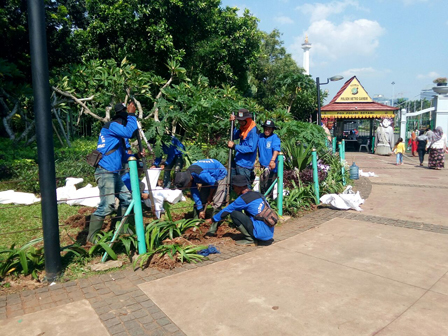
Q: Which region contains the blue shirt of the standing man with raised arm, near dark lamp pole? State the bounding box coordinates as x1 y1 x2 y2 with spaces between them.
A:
96 114 137 172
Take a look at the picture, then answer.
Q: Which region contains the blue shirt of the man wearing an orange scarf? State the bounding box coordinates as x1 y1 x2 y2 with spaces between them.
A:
233 127 258 169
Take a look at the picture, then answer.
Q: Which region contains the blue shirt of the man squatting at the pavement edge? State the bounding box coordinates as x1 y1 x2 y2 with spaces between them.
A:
212 191 274 240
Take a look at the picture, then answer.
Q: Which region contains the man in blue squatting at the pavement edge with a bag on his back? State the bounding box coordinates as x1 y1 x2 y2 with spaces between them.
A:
207 175 278 245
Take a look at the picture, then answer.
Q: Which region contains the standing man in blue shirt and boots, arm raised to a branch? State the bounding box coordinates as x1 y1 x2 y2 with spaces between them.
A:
87 102 137 242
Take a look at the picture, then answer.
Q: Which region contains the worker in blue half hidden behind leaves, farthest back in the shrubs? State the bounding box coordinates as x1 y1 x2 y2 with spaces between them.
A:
151 136 185 188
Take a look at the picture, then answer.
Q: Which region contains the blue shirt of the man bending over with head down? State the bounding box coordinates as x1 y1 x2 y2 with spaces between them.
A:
187 159 227 210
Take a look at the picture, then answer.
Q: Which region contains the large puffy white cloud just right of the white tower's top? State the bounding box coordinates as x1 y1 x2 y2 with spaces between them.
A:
291 19 385 62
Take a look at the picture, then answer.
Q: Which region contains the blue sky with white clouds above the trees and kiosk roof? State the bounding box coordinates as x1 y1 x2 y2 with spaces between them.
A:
222 0 448 103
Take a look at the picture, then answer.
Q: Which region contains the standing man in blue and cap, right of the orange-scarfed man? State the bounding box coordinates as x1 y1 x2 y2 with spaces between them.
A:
258 120 281 195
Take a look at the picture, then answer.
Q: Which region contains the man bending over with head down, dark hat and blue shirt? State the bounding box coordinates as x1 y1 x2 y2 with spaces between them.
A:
174 159 227 219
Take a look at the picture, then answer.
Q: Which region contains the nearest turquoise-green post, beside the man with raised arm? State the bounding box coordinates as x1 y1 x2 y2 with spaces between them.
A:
128 156 146 254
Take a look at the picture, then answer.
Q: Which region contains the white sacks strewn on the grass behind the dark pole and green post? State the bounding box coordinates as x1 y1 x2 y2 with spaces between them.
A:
0 168 185 217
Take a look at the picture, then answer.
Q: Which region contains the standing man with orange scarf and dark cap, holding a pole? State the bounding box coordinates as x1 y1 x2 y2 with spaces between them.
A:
227 109 258 188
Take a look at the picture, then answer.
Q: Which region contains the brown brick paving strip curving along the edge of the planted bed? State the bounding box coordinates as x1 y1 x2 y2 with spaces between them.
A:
0 178 448 336
